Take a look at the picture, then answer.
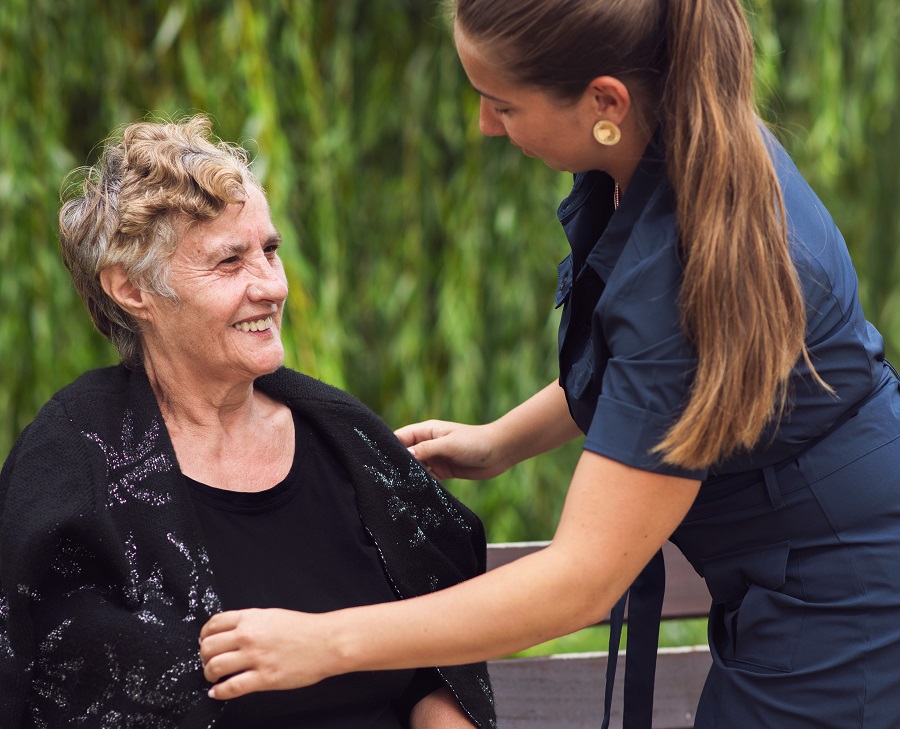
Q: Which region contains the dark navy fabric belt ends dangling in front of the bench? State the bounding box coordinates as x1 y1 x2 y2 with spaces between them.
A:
602 550 666 729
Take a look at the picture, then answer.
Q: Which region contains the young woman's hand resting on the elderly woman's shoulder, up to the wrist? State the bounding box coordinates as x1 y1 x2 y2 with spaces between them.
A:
395 420 511 480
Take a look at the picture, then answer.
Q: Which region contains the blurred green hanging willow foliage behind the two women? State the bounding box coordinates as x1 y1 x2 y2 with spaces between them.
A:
0 0 900 541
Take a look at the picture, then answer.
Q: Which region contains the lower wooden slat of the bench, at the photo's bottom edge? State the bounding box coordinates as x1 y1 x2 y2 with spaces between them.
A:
488 646 711 729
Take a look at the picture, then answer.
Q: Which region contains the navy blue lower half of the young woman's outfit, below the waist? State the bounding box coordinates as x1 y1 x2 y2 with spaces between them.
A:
672 379 900 729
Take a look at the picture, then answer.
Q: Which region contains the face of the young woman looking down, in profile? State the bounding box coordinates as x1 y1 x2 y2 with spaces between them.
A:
454 25 598 172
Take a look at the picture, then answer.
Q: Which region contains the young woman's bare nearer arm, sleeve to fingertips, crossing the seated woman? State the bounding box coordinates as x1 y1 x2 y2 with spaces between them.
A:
200 452 700 699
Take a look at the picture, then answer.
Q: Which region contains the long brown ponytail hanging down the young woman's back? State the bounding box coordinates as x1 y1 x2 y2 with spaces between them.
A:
655 0 824 468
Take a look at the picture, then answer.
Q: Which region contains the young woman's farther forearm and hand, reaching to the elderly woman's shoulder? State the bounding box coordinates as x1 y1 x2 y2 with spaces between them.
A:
396 380 581 479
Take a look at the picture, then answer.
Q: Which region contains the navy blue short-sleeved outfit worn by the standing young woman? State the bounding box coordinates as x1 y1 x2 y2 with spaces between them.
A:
556 134 900 729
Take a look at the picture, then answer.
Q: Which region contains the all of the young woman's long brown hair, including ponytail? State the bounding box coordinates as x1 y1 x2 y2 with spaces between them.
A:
454 0 827 469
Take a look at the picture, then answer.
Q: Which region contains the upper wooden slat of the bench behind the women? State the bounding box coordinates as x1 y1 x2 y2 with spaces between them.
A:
488 542 710 620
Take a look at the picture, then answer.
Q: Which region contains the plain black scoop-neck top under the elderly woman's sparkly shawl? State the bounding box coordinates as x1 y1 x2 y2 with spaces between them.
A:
187 414 443 729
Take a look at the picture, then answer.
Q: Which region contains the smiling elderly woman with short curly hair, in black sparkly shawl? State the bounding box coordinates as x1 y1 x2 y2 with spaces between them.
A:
0 117 494 729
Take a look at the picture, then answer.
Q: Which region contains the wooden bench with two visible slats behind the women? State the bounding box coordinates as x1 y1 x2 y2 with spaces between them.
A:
488 542 711 729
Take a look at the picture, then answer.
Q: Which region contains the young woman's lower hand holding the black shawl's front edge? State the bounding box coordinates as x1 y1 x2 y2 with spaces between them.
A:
200 608 337 700
